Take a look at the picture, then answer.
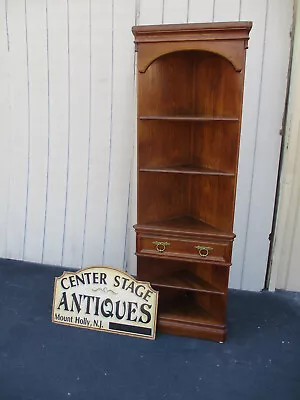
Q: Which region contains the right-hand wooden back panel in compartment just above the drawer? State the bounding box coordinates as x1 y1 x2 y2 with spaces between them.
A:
191 175 235 232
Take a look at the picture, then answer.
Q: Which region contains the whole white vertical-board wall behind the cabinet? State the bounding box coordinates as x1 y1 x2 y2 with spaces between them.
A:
0 0 293 290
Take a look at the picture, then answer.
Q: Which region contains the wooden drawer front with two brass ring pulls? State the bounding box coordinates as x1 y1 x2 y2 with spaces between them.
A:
137 235 232 263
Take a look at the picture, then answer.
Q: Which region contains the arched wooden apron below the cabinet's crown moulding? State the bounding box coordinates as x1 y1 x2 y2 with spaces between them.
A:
137 41 245 73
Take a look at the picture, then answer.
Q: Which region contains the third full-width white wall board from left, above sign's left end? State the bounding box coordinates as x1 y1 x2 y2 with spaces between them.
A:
43 0 69 265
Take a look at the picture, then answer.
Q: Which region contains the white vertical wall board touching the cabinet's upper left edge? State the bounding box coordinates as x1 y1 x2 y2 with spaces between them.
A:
103 0 135 268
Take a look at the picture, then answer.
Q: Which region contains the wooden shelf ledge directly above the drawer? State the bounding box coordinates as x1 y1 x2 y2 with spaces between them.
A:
135 216 235 239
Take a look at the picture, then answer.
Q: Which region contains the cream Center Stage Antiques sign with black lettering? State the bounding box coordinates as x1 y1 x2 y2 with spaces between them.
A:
52 267 158 339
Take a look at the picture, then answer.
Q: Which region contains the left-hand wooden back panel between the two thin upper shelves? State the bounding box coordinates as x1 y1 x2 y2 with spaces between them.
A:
138 121 191 168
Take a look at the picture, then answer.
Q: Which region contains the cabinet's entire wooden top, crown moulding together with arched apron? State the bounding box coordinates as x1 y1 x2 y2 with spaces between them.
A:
132 22 252 72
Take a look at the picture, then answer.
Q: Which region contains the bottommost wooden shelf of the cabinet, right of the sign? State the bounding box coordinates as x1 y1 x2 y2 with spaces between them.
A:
158 296 221 326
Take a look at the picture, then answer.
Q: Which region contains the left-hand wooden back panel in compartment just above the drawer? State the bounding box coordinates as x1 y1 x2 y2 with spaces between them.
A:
138 172 189 224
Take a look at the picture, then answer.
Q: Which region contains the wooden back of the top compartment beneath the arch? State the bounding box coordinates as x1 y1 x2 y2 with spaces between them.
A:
138 51 243 118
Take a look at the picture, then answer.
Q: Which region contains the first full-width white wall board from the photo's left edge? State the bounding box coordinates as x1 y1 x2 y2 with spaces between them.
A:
6 1 29 259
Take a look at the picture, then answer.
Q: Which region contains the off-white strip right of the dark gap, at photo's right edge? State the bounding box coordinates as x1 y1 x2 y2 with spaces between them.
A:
270 0 300 292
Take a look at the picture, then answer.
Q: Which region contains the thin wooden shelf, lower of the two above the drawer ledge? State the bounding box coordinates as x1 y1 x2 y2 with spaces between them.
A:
140 165 235 176
